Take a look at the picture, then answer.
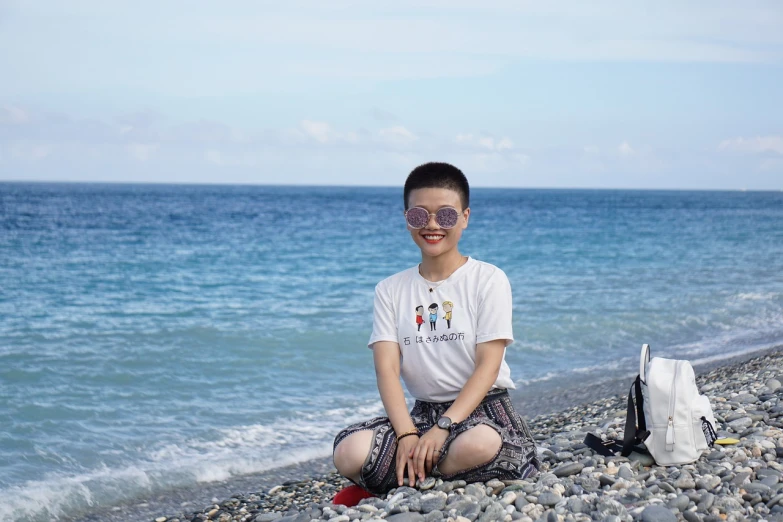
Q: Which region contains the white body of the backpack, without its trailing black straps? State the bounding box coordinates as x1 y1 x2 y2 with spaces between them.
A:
640 344 717 466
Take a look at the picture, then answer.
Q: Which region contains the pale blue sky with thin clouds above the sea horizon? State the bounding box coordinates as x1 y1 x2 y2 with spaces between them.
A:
0 0 783 190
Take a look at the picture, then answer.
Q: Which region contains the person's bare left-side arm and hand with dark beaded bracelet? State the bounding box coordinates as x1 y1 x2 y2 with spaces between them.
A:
373 341 419 487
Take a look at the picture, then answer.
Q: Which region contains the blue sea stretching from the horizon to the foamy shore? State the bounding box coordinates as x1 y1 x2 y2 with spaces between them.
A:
0 183 783 520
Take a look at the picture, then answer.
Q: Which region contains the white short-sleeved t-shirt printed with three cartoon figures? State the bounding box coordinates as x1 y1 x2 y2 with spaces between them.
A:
368 258 515 402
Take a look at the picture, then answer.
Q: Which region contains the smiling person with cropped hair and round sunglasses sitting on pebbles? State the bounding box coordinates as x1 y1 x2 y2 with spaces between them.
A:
333 163 540 504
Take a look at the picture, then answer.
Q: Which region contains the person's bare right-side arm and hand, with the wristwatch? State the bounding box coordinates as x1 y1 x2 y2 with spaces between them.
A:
413 339 506 480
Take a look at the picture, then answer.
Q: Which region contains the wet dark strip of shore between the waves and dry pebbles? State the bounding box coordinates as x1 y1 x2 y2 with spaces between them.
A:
69 345 783 522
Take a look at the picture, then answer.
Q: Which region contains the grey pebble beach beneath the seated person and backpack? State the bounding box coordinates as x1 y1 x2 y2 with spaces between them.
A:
144 347 783 522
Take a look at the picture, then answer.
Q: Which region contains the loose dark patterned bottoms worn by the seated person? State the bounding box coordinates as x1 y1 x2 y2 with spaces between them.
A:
334 389 540 494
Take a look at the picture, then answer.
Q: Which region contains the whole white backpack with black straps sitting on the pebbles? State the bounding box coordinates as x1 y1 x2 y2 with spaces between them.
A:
585 344 717 466
